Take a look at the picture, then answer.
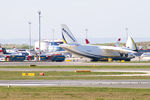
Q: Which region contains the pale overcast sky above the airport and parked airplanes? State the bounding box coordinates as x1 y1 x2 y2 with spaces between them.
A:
0 0 150 42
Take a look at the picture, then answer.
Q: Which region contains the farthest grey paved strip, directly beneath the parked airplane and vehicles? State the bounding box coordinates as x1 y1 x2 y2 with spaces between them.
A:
0 62 150 66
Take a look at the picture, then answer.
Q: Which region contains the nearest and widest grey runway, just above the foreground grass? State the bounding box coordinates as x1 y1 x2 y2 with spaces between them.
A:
0 80 150 88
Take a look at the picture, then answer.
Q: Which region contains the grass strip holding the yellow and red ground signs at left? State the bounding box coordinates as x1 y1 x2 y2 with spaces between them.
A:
0 71 146 80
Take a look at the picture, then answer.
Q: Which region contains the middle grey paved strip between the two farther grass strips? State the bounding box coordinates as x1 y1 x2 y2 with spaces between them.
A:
0 68 150 72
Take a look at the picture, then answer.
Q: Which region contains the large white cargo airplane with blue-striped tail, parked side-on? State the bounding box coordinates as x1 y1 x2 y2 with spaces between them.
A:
61 24 137 61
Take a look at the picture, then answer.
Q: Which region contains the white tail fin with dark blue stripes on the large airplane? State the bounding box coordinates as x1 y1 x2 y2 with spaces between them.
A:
61 24 77 44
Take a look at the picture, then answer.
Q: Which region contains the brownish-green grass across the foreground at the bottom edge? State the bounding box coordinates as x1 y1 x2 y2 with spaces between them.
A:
0 87 150 100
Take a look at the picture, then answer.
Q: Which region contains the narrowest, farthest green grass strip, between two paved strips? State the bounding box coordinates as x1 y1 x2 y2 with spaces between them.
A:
0 65 150 69
